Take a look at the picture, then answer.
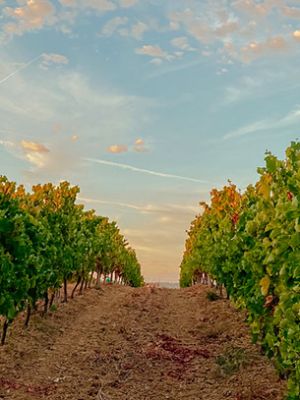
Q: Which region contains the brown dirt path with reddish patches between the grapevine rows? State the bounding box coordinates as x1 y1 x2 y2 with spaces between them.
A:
0 287 285 400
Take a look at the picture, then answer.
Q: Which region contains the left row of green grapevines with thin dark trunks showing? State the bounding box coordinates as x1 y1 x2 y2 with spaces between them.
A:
0 176 143 344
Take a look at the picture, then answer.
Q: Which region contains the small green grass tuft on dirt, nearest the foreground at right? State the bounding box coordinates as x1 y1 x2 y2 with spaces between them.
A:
216 347 250 375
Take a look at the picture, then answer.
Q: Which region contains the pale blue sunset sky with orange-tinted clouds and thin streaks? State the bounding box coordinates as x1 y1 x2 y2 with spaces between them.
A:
0 0 300 282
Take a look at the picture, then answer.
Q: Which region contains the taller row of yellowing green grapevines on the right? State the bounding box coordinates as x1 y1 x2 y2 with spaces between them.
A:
180 142 300 400
